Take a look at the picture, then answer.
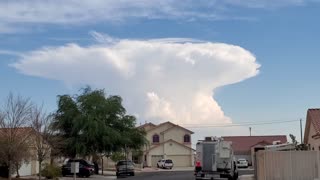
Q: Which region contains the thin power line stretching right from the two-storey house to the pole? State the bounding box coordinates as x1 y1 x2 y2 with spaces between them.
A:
180 120 300 128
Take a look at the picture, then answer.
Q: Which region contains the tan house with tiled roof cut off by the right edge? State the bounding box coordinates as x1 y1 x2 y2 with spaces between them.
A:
304 109 320 151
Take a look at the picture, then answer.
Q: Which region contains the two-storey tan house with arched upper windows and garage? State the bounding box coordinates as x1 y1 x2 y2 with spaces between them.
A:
139 122 195 167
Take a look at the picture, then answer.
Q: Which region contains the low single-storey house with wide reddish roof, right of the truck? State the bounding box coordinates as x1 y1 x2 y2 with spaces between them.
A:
223 135 287 164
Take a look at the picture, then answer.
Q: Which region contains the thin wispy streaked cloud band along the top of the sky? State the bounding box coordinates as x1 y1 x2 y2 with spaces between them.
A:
0 0 318 33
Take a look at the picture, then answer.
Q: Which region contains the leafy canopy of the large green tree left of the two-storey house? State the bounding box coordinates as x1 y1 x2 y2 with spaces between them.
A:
53 87 146 157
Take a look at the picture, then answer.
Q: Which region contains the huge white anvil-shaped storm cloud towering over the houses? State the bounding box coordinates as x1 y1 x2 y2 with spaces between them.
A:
13 34 260 124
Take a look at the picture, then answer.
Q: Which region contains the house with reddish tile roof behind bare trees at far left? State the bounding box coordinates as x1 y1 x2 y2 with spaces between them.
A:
0 127 50 176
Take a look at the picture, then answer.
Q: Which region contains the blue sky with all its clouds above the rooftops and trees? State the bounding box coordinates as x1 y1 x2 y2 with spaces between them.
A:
0 0 320 141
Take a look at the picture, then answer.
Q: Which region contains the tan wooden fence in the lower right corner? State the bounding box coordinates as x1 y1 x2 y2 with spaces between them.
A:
255 151 320 180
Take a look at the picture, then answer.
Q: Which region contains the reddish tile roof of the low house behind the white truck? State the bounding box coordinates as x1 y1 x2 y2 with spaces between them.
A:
222 135 287 154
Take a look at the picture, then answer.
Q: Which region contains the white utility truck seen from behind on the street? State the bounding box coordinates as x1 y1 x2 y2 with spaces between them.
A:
194 137 238 180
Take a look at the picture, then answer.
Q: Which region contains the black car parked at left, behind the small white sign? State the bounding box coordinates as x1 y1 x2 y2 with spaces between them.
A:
62 159 94 177
